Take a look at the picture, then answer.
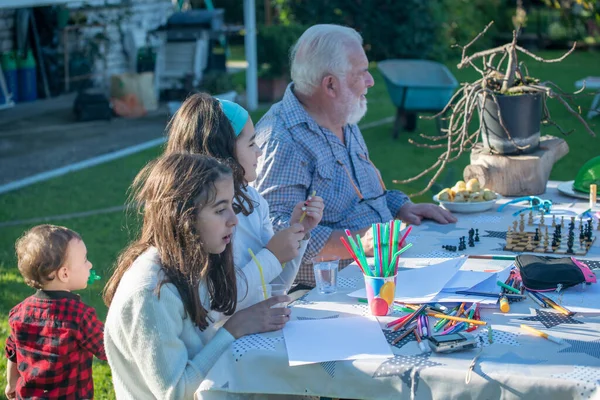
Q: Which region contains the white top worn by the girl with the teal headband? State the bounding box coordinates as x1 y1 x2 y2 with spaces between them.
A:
233 186 308 310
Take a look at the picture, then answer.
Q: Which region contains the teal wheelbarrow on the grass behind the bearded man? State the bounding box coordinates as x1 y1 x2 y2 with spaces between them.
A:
377 60 458 138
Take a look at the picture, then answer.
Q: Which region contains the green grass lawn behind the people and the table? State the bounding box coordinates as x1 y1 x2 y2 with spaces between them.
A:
0 52 600 399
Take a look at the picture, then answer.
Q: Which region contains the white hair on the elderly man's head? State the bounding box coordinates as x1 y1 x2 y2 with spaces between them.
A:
290 24 363 96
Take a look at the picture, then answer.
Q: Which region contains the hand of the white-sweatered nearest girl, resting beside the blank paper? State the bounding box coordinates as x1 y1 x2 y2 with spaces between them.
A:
223 296 292 339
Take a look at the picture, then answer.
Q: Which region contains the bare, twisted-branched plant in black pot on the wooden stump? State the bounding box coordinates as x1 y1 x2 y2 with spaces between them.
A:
394 22 596 196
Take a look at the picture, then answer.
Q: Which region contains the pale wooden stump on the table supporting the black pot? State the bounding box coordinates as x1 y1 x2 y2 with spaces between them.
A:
463 136 569 196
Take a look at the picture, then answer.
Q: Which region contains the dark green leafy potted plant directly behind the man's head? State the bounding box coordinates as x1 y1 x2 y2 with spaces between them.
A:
257 24 306 102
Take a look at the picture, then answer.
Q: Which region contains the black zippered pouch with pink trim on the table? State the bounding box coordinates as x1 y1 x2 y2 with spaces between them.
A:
515 255 595 291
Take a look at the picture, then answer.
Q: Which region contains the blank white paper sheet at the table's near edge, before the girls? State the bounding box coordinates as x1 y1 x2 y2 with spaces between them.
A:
283 317 394 366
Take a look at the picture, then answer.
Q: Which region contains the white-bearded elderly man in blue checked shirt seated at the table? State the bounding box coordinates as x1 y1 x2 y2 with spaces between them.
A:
254 25 456 286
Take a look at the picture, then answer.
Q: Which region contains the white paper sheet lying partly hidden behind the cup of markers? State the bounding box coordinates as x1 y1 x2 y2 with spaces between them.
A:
348 257 467 304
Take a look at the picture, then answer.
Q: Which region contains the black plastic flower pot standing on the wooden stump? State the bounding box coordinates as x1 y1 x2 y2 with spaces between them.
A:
478 93 543 154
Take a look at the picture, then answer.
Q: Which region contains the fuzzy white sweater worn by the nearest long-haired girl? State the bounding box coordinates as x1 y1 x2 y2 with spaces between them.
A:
104 248 234 400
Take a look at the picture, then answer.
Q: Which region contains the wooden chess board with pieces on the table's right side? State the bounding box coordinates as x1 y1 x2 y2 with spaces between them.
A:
504 223 596 256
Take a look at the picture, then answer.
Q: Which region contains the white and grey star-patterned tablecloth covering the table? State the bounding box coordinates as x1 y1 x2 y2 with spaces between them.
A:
196 182 600 400
